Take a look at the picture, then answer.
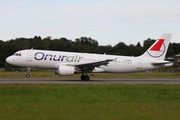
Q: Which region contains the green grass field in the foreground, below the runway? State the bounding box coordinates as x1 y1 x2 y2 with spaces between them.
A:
0 84 180 120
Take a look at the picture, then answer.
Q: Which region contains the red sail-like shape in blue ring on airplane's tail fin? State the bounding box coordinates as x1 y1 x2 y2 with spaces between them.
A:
147 39 166 58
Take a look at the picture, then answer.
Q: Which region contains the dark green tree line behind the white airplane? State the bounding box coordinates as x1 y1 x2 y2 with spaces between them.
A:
0 36 180 68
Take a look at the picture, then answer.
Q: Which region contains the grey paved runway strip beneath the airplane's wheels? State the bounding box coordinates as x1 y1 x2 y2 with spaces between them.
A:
0 78 180 84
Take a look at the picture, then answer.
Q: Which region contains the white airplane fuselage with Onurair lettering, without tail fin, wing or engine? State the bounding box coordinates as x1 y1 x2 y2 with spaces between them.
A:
6 50 164 73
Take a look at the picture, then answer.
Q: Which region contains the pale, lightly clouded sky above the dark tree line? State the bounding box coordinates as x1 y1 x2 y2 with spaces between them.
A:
0 0 180 46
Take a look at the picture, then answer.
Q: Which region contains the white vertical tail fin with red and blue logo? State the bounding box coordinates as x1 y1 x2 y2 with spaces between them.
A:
141 33 172 60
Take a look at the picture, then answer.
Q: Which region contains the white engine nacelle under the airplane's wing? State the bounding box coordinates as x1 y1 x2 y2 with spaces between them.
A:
54 65 74 75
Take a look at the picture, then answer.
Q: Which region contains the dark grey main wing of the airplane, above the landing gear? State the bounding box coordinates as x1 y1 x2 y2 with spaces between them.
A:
75 58 117 73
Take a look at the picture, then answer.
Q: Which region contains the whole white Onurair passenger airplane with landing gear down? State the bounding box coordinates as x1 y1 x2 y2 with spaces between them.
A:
6 33 172 81
